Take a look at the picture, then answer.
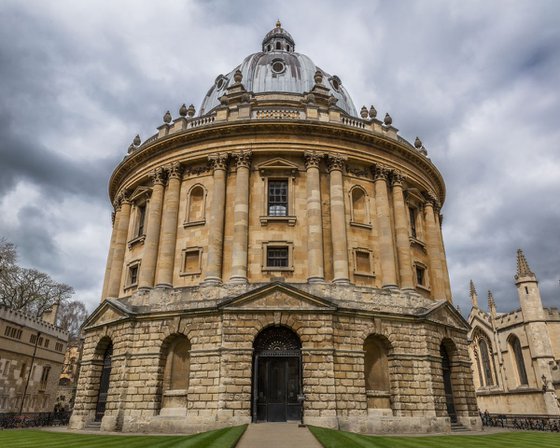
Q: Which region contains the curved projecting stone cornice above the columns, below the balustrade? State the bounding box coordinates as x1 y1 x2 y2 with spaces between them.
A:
109 120 445 203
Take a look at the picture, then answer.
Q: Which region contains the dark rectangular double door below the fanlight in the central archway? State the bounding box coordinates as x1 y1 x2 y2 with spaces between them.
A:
256 357 301 422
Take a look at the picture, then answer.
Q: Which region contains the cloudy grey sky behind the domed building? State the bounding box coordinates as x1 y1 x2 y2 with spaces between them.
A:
0 0 560 312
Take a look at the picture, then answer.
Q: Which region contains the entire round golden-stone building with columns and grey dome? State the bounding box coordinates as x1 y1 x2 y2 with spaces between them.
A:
71 23 479 433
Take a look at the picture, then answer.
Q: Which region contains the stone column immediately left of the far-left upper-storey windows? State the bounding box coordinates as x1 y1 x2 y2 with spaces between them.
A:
106 194 130 298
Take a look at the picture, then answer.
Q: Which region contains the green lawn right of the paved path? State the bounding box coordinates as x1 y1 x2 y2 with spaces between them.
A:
309 426 560 448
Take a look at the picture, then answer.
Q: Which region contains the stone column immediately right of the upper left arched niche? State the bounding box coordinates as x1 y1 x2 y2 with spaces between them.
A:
203 153 228 285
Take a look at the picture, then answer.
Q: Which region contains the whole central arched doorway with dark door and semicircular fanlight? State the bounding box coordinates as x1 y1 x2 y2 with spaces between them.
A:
253 327 302 422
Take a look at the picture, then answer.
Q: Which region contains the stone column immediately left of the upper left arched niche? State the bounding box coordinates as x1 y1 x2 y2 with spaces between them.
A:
156 162 182 288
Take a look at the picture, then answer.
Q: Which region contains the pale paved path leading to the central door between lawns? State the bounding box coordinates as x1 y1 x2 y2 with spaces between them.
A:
236 423 321 448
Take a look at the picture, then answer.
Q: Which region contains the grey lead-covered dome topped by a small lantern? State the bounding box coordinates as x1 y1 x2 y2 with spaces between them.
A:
200 22 357 117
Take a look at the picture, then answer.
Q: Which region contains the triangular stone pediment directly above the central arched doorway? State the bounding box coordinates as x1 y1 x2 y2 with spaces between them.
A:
220 283 336 311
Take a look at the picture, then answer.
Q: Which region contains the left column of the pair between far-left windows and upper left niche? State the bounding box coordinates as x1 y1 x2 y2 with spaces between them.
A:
138 168 165 288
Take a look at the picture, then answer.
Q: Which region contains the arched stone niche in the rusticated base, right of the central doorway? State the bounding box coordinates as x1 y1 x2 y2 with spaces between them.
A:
364 335 391 409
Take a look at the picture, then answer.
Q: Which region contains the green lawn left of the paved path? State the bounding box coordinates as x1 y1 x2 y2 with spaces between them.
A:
0 425 247 448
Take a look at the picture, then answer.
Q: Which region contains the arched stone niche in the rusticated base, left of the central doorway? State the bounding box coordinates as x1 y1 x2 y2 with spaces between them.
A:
161 334 191 415
